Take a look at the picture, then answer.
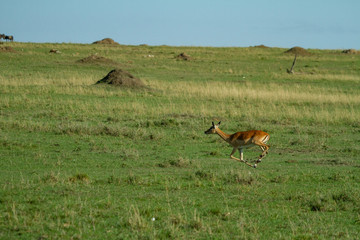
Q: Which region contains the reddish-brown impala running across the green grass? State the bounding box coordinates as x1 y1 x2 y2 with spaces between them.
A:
205 122 270 168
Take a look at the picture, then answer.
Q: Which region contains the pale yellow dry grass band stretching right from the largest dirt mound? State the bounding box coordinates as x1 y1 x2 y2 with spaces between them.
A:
150 81 360 104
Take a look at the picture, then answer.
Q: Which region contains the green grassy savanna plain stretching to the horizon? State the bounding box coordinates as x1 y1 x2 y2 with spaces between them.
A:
0 43 360 239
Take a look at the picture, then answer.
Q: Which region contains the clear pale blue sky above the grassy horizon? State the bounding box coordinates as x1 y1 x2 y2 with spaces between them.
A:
0 0 360 49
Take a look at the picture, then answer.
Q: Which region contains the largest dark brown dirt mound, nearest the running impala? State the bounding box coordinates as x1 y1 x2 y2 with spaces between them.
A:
96 69 145 88
